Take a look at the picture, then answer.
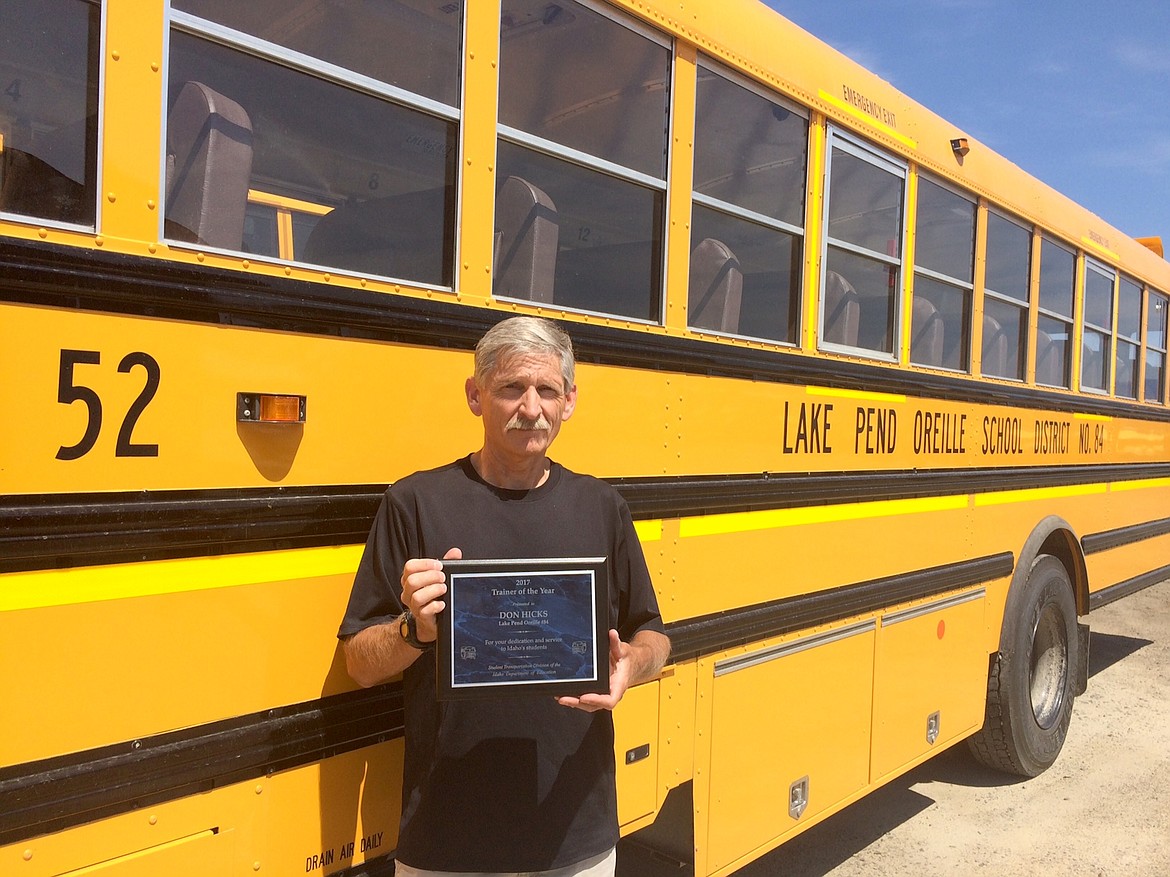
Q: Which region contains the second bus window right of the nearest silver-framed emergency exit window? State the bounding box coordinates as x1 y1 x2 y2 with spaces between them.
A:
983 210 1032 381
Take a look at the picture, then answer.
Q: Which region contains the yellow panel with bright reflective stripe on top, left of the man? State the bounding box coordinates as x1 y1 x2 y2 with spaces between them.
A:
0 548 358 765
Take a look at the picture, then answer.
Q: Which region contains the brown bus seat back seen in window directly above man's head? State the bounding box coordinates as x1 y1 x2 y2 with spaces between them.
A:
493 177 560 303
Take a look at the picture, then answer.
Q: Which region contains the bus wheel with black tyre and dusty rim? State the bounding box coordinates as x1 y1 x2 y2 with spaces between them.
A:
969 554 1078 776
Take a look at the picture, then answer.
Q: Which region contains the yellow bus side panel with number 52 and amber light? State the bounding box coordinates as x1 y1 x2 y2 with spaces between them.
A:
0 306 482 493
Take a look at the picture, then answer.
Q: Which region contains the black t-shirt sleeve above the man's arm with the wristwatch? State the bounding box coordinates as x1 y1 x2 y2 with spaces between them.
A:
337 491 412 637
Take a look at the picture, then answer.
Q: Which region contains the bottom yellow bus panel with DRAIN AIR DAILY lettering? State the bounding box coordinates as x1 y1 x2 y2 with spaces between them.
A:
0 740 401 877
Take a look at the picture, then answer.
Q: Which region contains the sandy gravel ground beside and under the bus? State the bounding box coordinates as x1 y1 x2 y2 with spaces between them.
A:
736 581 1170 877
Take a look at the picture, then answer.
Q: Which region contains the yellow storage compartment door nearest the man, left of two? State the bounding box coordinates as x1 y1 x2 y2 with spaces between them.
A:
695 623 874 875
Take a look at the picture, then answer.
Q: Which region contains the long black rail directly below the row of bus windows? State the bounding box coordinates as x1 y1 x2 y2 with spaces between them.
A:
0 239 1170 422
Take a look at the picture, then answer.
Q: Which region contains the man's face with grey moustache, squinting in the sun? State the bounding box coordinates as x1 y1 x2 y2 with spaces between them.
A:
467 353 577 460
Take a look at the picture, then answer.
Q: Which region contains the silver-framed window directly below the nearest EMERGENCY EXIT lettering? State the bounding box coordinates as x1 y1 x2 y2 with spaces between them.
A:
820 131 906 357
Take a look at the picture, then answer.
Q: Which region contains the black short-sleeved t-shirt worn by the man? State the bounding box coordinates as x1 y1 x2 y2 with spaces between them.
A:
339 457 663 871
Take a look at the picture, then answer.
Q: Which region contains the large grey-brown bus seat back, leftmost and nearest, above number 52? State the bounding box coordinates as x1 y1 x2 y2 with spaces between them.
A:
166 82 252 250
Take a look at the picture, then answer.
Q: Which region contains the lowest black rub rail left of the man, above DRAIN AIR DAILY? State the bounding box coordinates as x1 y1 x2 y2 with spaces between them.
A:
0 683 404 847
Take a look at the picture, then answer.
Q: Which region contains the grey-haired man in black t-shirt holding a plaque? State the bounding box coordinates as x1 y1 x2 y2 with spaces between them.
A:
338 317 670 877
